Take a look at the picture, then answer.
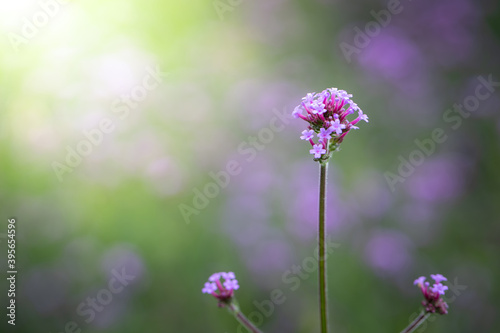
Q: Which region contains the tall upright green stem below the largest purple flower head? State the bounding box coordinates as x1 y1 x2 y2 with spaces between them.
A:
318 162 328 333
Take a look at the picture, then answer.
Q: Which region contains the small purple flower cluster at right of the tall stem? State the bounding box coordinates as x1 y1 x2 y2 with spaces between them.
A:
413 274 448 314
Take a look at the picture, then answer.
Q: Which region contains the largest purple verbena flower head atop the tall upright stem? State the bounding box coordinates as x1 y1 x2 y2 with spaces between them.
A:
292 88 368 162
